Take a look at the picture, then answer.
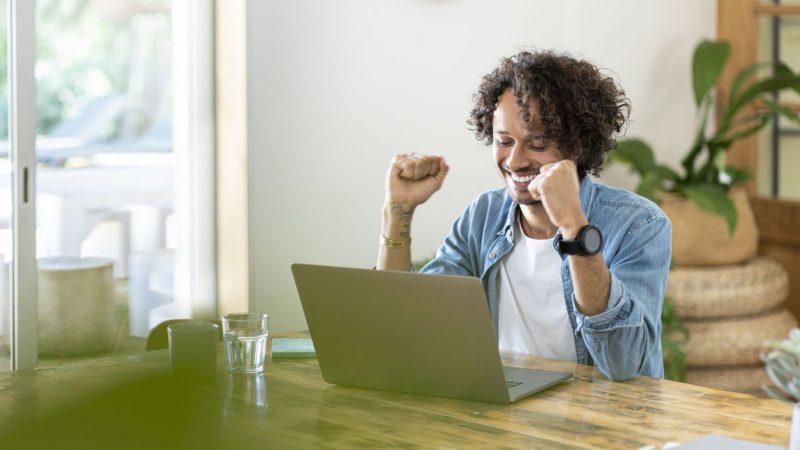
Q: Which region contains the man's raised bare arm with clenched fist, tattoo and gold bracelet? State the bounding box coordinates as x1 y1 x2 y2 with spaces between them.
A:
376 153 449 271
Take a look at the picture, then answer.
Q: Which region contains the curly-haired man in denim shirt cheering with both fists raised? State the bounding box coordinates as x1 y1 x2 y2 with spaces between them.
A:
377 52 672 380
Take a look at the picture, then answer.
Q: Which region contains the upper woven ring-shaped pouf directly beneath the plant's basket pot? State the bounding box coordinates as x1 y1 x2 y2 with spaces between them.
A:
667 257 789 319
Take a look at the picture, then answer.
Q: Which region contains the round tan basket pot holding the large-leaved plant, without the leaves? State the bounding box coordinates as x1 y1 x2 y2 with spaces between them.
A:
660 189 758 266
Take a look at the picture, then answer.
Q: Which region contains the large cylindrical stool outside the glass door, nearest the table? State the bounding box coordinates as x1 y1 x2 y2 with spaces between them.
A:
38 257 115 356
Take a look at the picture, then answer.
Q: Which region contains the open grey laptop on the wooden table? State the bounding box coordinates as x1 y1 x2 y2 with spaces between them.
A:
292 264 573 403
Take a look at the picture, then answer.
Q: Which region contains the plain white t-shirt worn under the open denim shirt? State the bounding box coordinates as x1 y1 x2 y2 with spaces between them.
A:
498 215 577 361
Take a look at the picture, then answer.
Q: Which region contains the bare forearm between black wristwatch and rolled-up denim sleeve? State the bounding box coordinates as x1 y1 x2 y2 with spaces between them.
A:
569 253 611 316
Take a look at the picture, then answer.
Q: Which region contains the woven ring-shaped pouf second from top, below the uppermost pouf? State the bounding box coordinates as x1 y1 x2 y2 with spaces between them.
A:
686 307 797 368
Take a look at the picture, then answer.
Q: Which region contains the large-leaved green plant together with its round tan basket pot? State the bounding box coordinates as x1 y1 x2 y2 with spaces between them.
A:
610 40 800 265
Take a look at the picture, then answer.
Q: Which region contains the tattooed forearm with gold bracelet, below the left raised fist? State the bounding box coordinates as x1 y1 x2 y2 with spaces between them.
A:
376 203 414 271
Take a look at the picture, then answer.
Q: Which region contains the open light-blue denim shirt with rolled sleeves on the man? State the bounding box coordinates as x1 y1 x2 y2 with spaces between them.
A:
422 176 672 380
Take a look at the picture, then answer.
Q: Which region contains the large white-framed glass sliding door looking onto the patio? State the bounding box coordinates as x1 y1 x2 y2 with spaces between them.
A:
0 0 216 368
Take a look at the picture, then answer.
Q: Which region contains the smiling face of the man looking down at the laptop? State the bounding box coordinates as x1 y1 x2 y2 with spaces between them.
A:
492 89 564 205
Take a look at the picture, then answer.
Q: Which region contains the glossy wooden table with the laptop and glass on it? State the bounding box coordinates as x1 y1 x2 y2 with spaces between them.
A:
0 345 791 449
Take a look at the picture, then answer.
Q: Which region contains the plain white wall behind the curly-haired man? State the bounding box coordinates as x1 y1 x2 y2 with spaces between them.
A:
247 0 715 331
